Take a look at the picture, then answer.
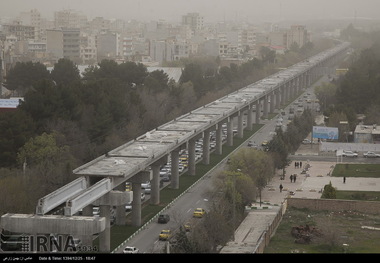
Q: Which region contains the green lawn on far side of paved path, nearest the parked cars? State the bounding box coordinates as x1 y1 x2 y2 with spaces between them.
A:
331 163 380 178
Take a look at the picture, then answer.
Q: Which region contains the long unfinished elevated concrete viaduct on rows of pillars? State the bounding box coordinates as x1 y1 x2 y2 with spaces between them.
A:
0 43 349 252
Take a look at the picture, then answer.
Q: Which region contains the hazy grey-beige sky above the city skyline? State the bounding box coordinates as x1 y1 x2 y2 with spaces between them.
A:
0 0 380 22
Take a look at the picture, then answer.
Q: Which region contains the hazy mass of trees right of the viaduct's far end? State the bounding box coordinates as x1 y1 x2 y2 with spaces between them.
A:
315 25 380 135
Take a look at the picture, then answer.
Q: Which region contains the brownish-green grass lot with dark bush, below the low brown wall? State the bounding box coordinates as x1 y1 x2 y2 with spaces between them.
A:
264 208 380 253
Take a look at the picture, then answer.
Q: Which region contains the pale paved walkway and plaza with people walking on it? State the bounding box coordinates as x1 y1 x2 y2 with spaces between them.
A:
221 161 380 253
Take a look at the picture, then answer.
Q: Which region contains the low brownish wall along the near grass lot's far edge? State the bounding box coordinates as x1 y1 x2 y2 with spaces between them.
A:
287 198 380 214
